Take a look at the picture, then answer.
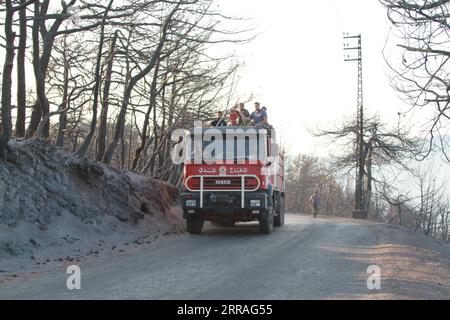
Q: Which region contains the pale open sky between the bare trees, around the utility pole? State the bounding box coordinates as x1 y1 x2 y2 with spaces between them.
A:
219 0 406 156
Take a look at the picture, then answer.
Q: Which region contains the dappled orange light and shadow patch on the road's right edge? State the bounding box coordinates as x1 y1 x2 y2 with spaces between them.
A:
320 243 450 299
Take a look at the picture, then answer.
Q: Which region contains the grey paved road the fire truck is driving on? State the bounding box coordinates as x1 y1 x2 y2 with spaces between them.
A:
0 215 450 300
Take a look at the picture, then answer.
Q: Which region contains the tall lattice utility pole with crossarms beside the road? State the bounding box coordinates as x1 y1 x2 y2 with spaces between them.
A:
344 33 368 219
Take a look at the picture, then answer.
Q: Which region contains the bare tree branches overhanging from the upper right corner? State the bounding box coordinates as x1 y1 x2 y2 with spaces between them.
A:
380 0 450 162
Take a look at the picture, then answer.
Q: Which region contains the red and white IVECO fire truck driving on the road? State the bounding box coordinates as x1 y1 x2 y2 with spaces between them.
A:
182 127 285 234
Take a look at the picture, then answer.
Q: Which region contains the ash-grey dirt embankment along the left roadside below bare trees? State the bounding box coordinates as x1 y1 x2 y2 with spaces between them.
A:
0 141 182 269
